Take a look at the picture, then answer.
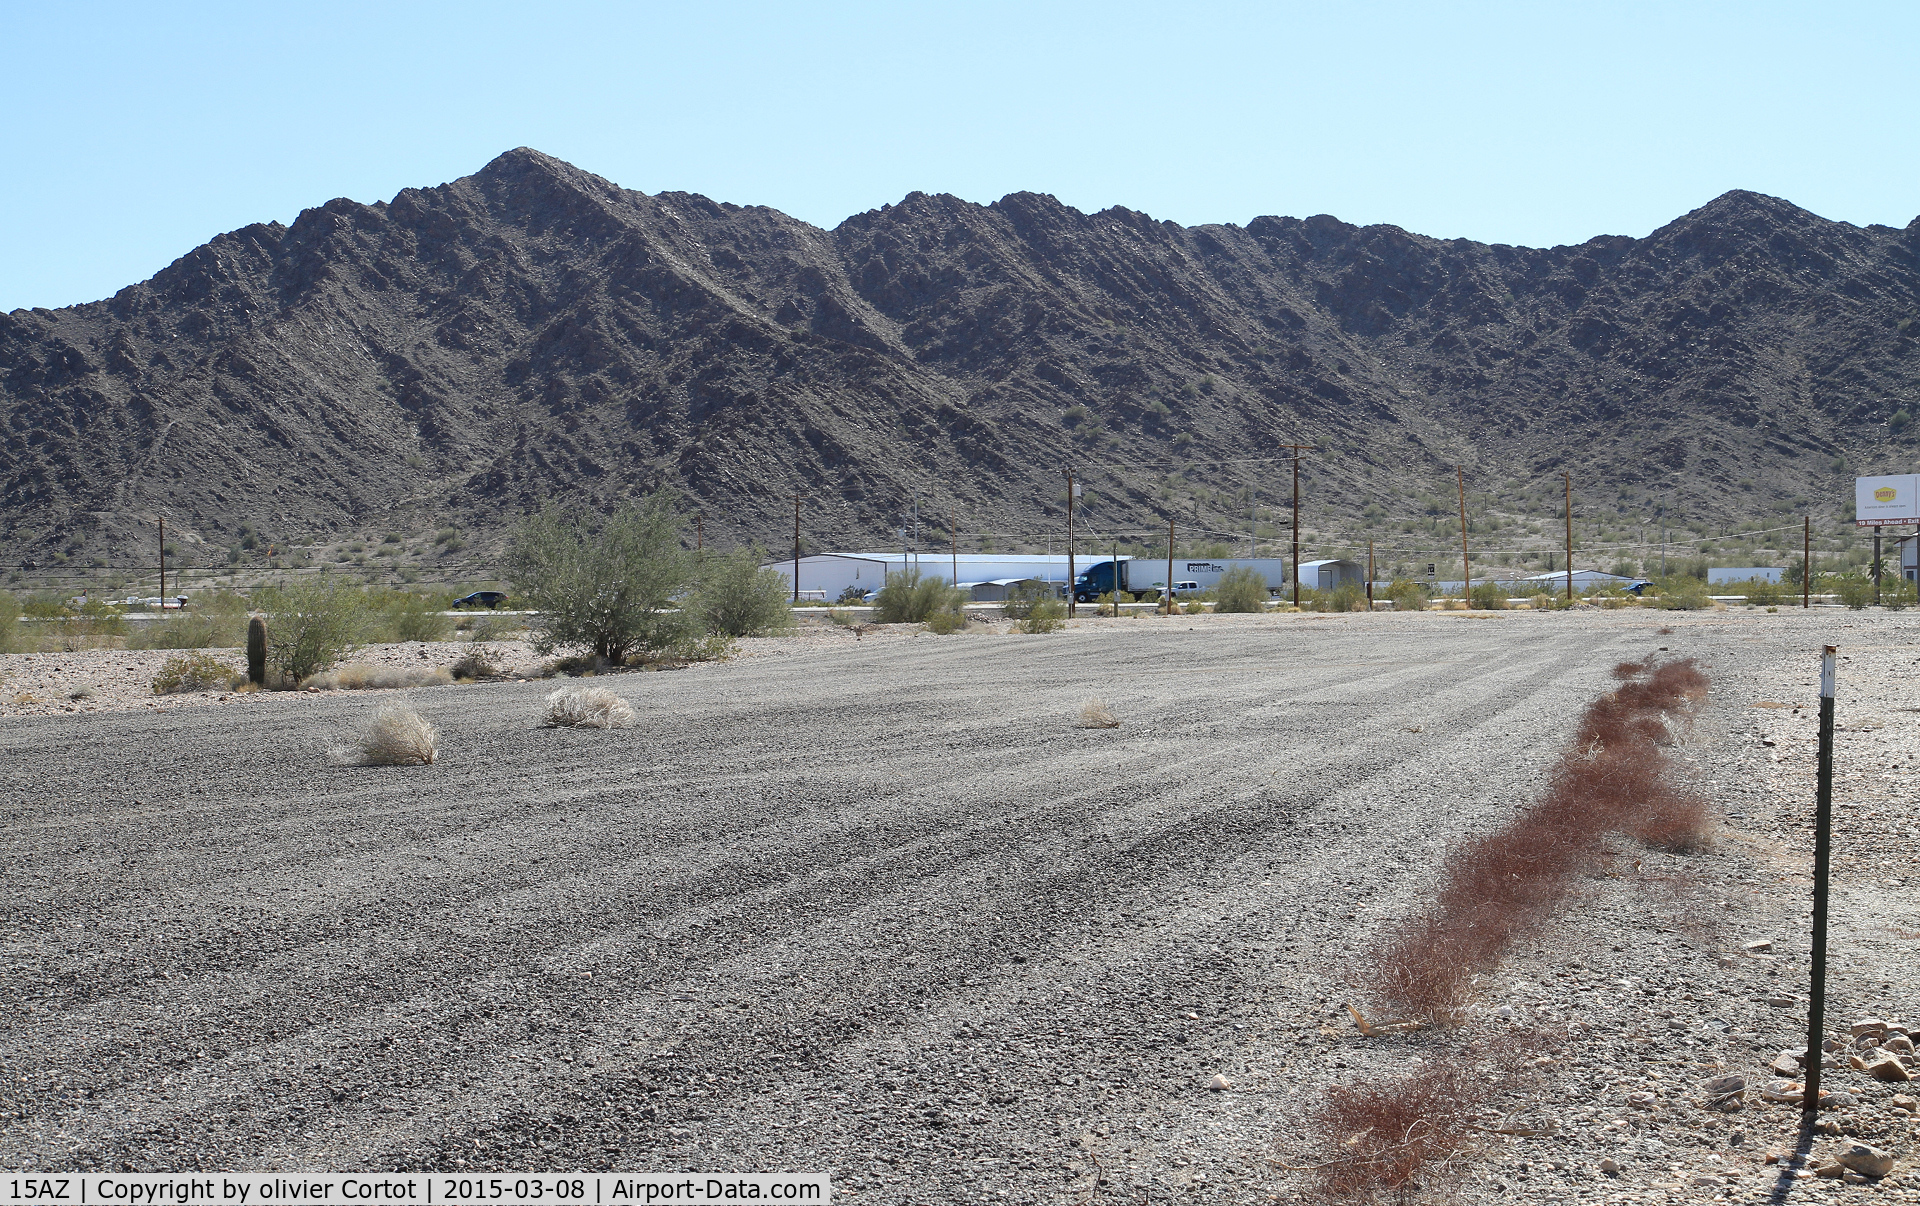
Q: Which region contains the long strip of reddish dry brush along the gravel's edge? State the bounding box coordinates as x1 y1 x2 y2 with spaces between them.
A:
1367 657 1707 1020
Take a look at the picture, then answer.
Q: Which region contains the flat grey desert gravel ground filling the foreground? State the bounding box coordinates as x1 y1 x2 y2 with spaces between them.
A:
0 611 1920 1202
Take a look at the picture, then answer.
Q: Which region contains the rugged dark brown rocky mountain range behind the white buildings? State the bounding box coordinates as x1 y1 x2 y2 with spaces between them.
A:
0 148 1920 561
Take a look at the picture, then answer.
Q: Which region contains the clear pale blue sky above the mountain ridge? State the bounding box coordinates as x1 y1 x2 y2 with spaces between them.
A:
0 0 1920 311
